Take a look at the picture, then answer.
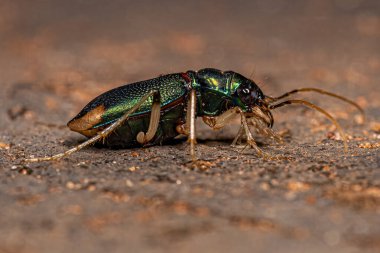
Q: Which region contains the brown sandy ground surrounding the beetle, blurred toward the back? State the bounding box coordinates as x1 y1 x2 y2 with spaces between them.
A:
0 0 380 253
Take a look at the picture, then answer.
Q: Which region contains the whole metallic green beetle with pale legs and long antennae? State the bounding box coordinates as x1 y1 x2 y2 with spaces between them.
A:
26 68 364 162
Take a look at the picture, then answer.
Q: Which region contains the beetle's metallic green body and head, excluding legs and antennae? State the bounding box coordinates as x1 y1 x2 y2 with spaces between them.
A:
68 68 271 147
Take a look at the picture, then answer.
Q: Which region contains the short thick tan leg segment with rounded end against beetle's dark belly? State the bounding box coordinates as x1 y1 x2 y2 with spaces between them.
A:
136 92 161 144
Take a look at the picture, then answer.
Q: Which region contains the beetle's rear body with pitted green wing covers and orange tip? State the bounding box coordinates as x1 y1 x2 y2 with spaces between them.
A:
68 74 190 147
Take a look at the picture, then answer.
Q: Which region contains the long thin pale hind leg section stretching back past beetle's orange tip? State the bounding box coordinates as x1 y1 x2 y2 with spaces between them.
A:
24 90 158 162
